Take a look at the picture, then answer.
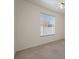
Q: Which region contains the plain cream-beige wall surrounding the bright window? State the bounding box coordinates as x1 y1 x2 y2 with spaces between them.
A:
15 0 64 51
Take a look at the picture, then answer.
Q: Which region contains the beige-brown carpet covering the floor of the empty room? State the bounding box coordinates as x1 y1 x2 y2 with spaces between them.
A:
15 40 65 59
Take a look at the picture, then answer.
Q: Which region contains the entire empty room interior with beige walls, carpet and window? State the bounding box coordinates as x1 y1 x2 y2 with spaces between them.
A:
14 0 65 59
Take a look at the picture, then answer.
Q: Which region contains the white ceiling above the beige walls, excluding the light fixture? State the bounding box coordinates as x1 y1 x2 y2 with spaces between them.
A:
25 0 65 14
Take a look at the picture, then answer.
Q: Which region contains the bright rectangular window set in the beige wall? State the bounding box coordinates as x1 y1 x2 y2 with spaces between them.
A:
40 13 55 36
